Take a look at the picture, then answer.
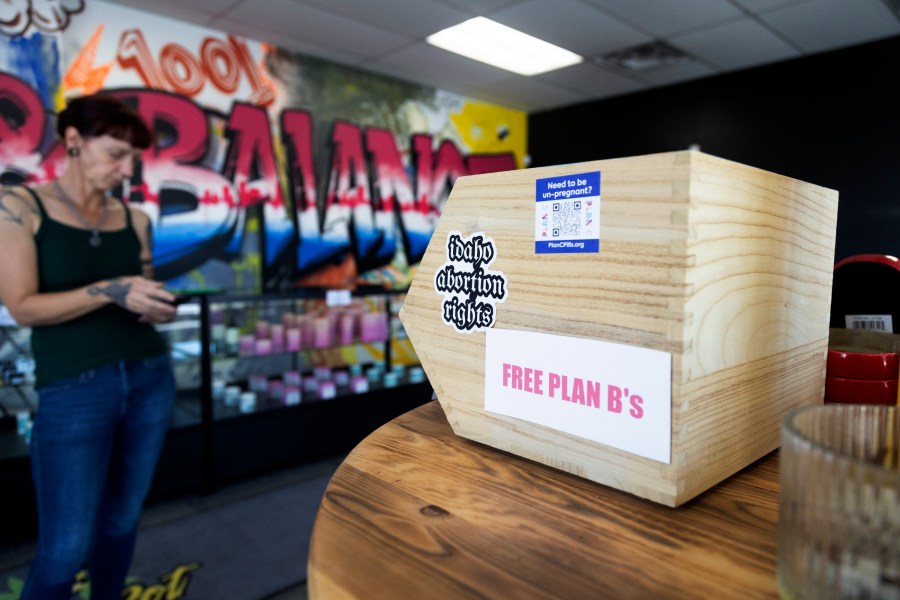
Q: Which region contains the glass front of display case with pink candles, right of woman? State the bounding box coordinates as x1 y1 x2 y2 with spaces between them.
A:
159 290 425 421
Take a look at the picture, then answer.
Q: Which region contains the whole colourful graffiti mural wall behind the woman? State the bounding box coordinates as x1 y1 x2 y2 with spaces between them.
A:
0 0 526 291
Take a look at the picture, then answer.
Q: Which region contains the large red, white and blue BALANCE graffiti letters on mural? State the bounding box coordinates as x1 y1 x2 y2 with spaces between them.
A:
0 72 516 289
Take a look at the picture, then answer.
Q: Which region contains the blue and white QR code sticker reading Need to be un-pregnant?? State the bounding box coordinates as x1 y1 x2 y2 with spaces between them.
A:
534 171 600 254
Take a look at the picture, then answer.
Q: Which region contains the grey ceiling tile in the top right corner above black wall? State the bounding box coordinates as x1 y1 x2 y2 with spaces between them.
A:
760 0 900 52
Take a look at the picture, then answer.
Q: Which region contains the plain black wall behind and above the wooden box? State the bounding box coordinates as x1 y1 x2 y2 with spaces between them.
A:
528 37 900 260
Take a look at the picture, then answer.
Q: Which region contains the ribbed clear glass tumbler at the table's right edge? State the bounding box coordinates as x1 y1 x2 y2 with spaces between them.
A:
778 404 900 600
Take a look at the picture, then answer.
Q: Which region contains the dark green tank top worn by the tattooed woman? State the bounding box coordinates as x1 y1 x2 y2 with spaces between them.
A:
26 188 167 388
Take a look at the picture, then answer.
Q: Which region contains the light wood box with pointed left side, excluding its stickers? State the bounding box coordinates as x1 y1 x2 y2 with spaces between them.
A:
400 151 838 506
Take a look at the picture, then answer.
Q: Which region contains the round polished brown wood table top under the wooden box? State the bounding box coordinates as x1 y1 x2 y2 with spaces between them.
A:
308 401 778 600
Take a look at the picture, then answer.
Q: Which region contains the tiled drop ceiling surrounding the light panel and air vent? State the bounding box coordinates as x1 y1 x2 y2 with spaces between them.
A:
102 0 900 112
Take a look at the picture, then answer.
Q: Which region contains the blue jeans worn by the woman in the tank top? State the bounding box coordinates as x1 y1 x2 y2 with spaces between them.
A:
22 355 175 600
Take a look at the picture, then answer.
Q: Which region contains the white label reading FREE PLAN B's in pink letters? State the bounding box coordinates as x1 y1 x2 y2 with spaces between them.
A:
484 328 672 464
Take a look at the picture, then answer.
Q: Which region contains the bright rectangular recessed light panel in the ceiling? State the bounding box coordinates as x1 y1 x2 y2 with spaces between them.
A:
425 17 583 76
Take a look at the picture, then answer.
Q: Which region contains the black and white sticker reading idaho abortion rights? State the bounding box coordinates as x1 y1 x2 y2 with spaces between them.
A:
434 231 508 333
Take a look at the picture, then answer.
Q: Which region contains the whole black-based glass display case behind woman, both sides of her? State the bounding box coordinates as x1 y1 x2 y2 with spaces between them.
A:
0 288 431 497
